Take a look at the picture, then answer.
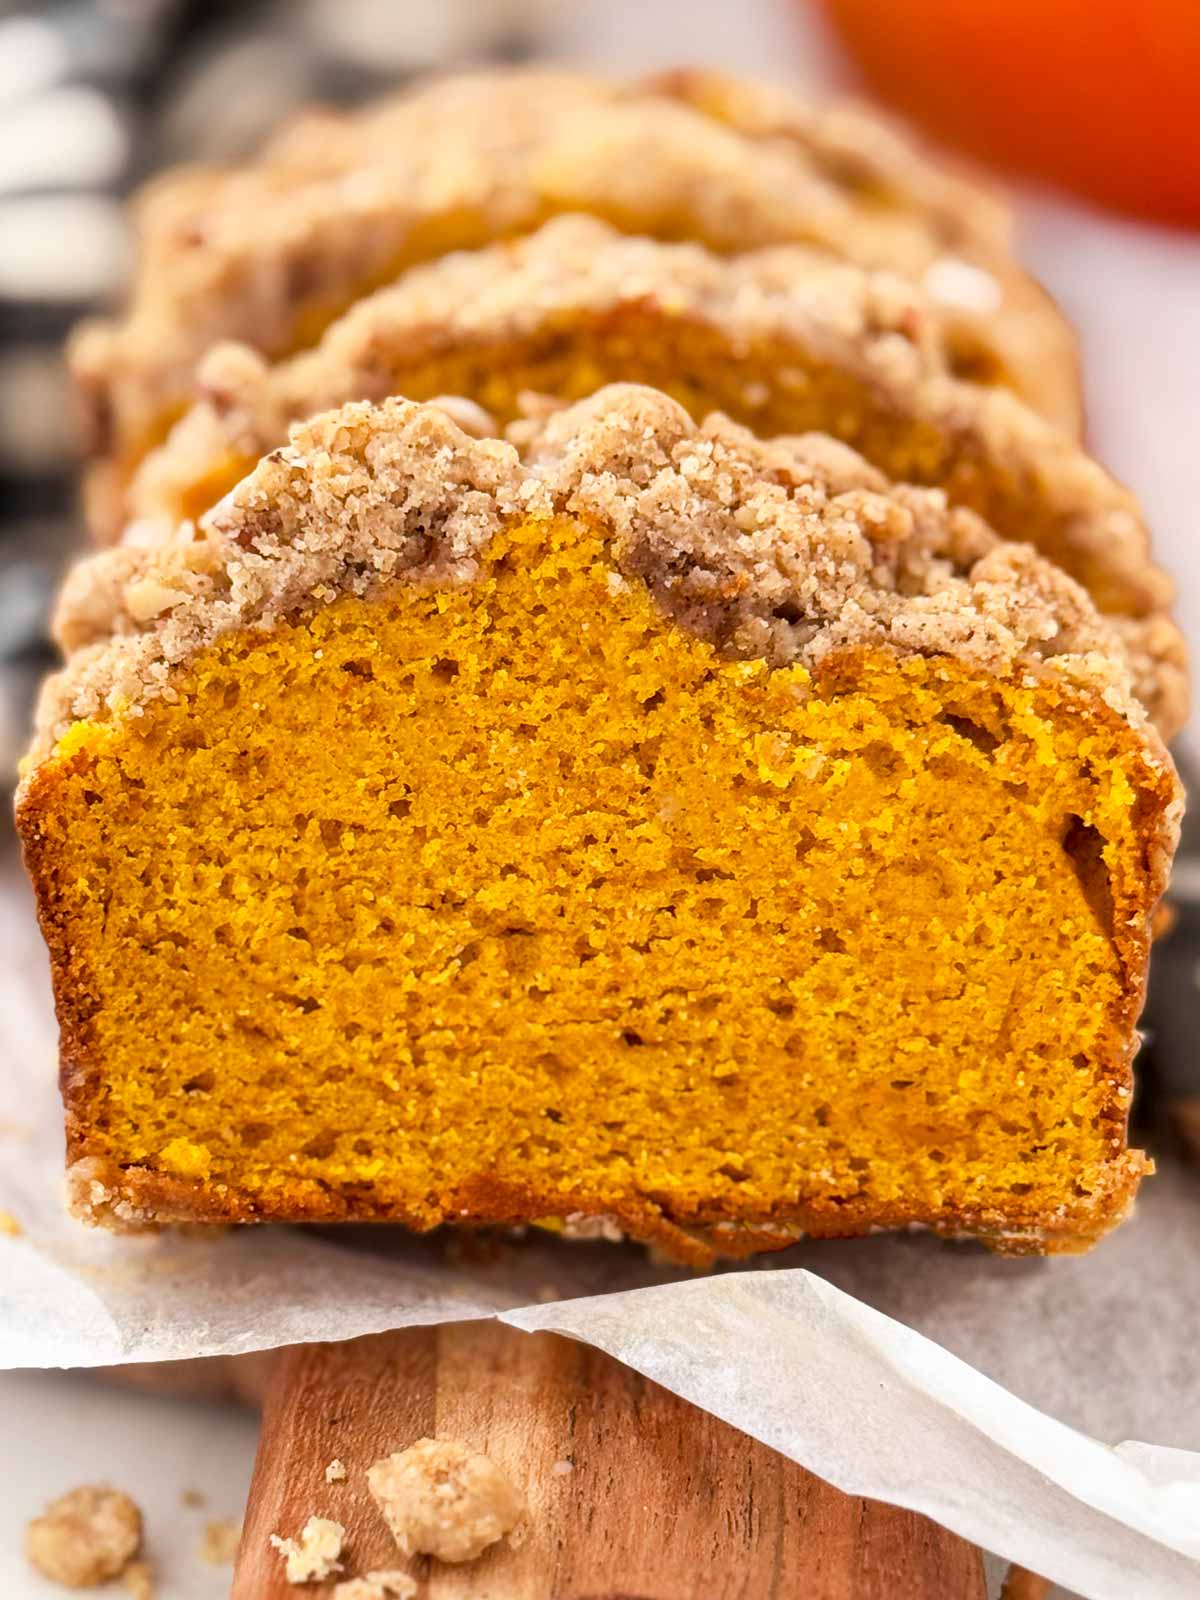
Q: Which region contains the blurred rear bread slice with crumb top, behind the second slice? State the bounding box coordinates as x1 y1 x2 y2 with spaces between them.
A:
72 70 1077 538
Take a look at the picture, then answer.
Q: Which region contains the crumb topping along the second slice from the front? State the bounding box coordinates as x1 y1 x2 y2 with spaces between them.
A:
120 216 1186 725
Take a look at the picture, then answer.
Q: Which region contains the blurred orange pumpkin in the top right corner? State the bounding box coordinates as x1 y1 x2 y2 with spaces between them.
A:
822 0 1200 227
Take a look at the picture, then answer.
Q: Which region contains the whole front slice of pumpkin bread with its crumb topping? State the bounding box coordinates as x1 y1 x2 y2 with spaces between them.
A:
18 386 1179 1261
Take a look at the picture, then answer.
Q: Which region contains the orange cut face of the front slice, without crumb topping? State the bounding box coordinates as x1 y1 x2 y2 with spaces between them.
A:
21 390 1173 1259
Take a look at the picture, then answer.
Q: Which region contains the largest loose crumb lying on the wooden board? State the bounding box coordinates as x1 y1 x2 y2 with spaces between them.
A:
366 1438 528 1562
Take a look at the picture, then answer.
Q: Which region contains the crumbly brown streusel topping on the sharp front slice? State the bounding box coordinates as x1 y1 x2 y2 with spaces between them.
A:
30 386 1146 780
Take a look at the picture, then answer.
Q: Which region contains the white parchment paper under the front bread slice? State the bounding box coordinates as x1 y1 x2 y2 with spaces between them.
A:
0 874 1200 1600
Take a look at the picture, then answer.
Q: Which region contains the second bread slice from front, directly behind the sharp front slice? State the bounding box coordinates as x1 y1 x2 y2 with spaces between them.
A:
120 216 1187 738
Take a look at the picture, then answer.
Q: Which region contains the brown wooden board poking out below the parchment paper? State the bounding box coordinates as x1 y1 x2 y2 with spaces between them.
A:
232 1322 986 1600
